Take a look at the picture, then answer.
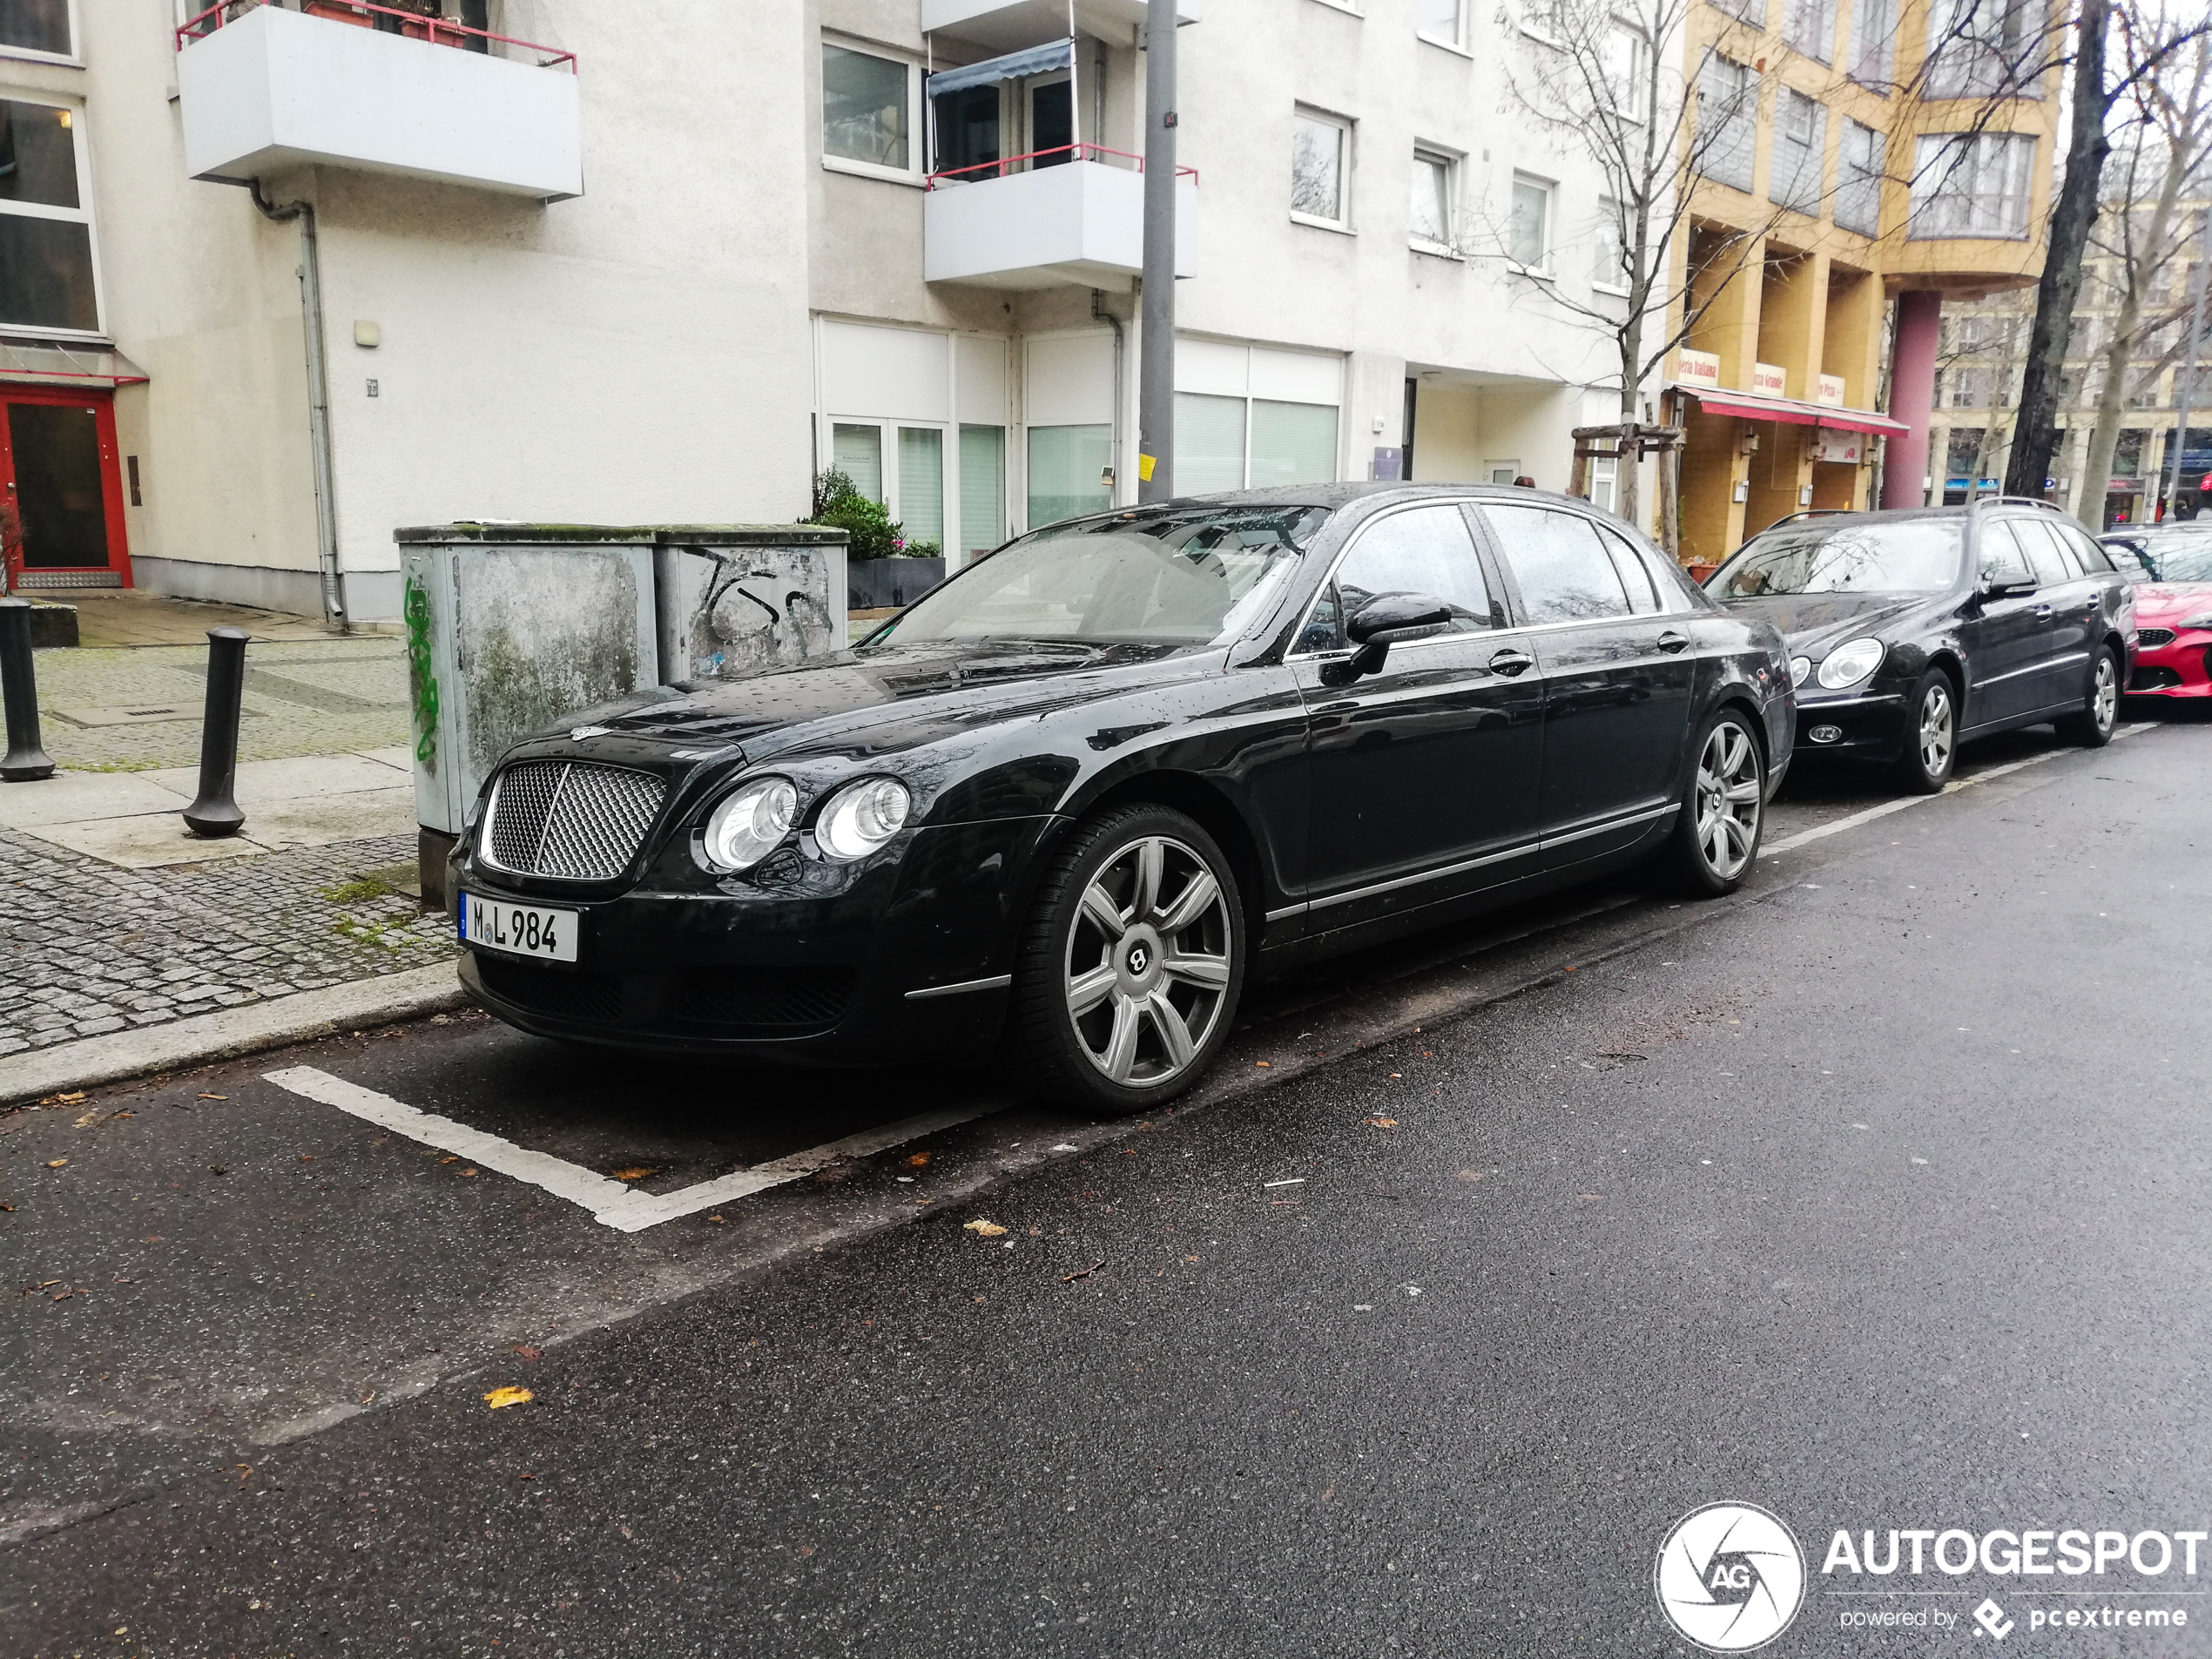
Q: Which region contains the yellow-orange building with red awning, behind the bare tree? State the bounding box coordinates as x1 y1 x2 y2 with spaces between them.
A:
1668 0 2060 560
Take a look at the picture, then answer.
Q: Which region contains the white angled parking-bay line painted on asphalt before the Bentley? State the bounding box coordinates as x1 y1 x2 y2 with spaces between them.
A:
266 1066 1008 1232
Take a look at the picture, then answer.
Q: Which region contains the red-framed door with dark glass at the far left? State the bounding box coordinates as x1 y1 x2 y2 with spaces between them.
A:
0 385 131 590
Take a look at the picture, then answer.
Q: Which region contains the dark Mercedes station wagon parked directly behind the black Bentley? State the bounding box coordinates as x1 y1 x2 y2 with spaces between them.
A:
1705 498 2134 794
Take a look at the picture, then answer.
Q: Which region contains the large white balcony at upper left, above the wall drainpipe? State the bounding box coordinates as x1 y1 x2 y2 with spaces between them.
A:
177 4 584 201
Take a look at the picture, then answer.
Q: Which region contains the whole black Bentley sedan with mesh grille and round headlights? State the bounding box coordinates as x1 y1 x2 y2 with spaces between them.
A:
447 484 1791 1113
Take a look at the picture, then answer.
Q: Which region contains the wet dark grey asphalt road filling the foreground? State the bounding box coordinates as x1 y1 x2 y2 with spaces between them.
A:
0 707 2212 1656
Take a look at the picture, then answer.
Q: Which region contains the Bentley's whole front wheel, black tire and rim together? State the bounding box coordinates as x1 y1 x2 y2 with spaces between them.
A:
1007 806 1245 1117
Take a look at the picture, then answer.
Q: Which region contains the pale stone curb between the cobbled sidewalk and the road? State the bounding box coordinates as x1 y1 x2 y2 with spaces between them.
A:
0 962 469 1106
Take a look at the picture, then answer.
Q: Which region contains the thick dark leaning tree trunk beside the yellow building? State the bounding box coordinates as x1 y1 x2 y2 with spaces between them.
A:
2004 0 2113 496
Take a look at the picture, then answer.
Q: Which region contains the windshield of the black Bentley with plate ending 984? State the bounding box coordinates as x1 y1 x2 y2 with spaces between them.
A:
869 507 1327 646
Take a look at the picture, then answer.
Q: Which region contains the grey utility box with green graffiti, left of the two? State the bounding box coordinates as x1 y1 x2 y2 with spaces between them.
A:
396 524 661 836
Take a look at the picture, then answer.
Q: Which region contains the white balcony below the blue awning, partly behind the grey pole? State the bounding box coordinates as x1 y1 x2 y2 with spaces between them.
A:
922 146 1199 287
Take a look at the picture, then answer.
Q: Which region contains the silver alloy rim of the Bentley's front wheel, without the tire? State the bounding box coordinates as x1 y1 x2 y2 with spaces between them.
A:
1064 836 1237 1089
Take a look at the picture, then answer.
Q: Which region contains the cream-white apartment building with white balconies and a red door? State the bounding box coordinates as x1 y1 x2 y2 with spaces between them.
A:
0 0 1663 622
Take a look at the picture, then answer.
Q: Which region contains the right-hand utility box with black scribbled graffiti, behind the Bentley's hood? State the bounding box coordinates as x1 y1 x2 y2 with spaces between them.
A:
652 524 847 681
